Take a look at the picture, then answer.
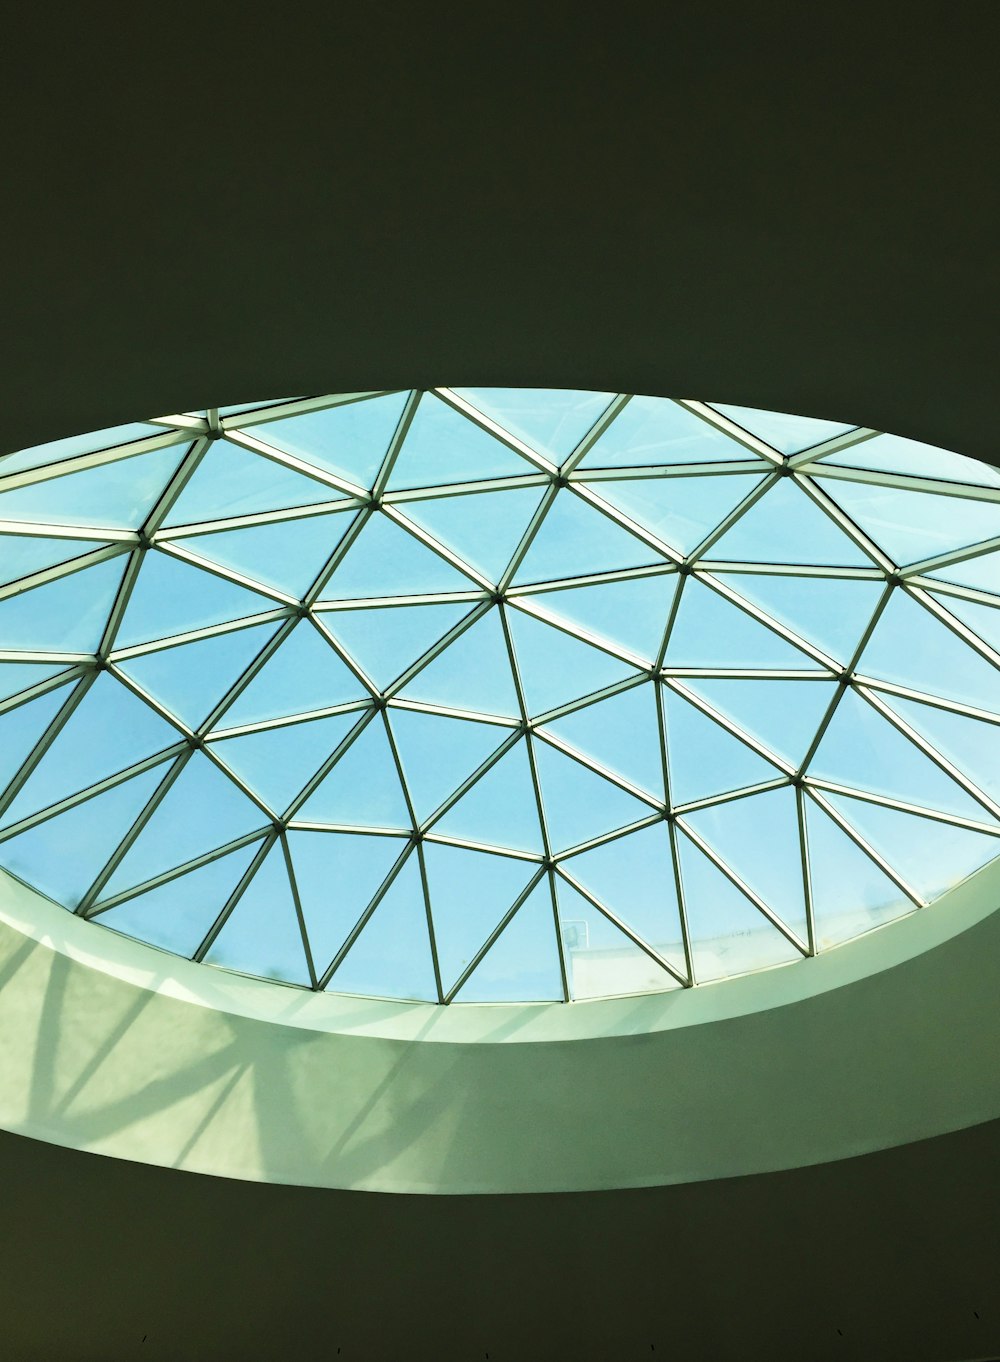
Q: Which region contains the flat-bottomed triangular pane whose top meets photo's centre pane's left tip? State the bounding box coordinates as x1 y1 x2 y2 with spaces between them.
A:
296 718 411 832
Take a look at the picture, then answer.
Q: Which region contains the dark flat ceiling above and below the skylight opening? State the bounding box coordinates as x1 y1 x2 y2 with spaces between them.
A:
0 3 1000 1362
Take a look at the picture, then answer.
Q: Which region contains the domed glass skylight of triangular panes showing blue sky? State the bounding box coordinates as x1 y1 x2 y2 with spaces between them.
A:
0 390 1000 1002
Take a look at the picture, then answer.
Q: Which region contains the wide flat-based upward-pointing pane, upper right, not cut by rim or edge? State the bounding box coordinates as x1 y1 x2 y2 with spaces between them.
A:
706 478 873 568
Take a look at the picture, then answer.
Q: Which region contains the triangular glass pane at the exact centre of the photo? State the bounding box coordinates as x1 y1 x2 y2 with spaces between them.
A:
401 610 520 718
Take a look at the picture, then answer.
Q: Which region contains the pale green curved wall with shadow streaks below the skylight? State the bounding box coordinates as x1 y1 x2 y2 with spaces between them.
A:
0 865 1000 1193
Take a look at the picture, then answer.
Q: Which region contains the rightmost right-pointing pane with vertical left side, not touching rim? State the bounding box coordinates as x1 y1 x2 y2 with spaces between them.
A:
663 689 782 804
